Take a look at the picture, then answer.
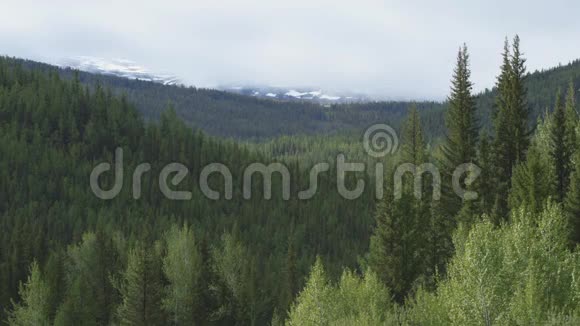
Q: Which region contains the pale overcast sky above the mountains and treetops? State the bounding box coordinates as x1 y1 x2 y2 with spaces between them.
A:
0 0 580 100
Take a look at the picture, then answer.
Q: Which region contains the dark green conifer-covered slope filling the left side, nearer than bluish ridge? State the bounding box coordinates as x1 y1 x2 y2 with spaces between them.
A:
0 59 374 325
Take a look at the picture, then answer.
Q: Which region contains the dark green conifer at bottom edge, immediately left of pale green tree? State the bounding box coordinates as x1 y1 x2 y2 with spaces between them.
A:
118 244 164 326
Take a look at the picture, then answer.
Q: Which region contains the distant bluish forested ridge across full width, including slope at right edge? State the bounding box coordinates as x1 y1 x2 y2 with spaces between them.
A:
10 54 580 141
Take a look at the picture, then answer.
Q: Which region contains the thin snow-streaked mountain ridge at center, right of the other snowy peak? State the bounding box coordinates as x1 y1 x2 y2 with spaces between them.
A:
218 86 370 104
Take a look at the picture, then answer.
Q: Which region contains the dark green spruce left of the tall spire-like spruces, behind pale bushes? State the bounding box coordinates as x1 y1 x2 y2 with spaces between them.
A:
369 107 431 303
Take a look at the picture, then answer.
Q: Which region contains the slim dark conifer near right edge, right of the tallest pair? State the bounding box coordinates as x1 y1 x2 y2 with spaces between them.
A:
550 90 573 202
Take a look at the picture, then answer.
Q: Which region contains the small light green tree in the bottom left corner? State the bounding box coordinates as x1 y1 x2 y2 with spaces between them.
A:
8 262 50 326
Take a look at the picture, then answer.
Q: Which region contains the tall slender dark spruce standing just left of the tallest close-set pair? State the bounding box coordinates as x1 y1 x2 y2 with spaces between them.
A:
442 44 479 216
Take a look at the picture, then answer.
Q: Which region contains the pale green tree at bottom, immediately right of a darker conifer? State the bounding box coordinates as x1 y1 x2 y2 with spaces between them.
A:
163 225 202 325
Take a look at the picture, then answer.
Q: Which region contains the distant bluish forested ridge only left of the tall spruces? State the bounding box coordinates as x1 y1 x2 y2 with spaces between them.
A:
8 59 443 140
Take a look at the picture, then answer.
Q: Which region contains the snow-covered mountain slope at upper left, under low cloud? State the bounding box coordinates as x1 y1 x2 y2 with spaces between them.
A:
58 56 180 85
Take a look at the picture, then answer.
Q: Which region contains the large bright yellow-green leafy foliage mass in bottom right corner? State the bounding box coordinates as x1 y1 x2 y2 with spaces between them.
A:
430 204 580 325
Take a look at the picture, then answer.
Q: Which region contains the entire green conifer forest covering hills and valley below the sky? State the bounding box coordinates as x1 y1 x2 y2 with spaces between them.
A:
0 36 580 325
